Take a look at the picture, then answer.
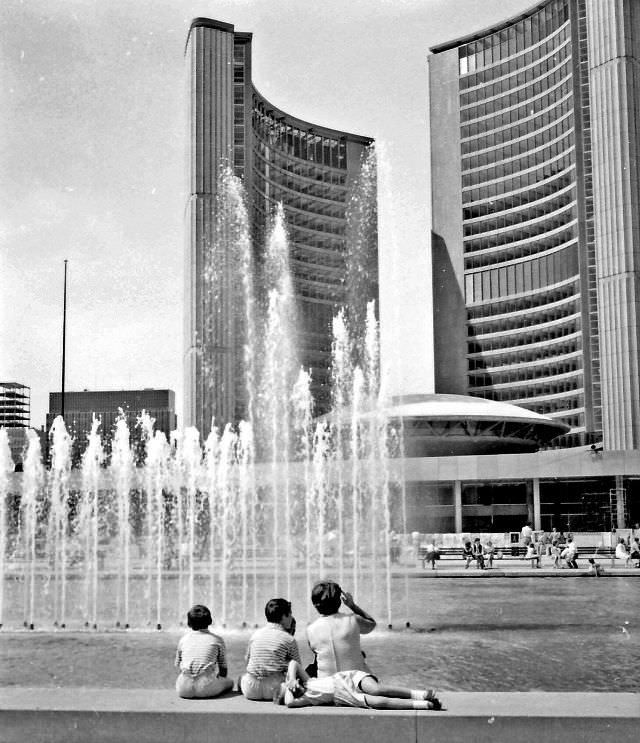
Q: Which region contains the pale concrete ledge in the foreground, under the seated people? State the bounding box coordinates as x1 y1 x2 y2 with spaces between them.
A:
0 687 640 743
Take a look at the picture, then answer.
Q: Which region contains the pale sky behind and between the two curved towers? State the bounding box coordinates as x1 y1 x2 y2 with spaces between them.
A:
0 0 533 427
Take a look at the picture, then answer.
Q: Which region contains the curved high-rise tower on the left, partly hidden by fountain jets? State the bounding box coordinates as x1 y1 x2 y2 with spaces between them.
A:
184 18 378 436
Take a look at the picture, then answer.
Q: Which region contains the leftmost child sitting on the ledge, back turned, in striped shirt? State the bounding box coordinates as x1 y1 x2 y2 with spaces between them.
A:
176 604 233 699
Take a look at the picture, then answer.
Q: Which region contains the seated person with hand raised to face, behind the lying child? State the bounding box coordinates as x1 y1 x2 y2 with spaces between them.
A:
307 580 376 678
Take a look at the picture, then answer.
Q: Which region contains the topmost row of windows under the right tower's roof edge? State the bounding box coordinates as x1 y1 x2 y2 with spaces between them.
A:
458 0 569 79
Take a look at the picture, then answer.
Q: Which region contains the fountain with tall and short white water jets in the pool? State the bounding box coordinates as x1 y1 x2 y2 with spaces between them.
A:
0 151 410 629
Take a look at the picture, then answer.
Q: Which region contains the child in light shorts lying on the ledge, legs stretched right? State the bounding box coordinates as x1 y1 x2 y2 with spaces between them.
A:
273 660 442 710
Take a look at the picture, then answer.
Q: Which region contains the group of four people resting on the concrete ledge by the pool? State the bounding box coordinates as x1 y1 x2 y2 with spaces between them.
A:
175 581 442 710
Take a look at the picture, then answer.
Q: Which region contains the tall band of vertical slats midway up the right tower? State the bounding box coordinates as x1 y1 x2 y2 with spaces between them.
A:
465 245 579 303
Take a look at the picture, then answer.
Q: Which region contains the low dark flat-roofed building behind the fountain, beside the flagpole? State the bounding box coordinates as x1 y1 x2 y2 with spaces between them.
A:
47 389 177 450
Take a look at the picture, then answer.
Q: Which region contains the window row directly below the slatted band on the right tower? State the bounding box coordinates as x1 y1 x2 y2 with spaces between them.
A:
467 281 579 322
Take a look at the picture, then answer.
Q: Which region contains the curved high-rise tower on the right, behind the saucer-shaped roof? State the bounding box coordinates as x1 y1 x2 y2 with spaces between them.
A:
429 0 640 450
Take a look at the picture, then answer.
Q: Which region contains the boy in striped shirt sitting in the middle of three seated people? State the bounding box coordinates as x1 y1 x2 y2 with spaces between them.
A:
240 599 300 700
